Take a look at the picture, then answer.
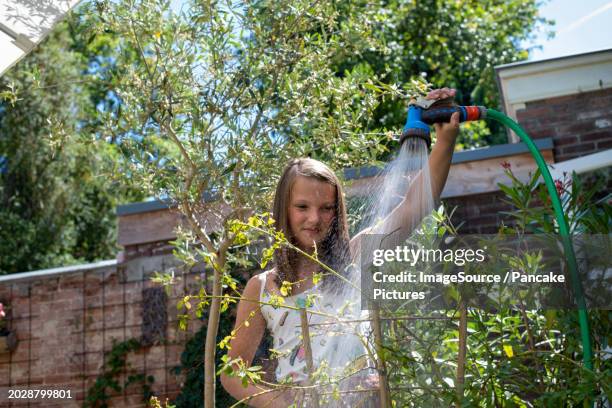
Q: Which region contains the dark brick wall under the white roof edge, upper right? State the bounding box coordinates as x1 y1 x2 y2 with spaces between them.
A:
517 88 612 162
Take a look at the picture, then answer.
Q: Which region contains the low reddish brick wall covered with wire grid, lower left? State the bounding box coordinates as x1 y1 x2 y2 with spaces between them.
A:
0 256 210 407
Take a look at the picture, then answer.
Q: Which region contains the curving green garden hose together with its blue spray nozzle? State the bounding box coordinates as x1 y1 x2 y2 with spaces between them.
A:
399 97 593 376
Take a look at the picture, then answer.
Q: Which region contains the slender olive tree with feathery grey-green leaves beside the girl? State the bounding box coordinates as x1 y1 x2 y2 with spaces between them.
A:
95 0 393 407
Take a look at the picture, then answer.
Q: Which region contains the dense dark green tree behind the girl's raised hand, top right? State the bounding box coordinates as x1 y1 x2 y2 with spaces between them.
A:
334 0 551 148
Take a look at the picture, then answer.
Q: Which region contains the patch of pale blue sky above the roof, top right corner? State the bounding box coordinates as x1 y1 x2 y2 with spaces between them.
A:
524 0 612 61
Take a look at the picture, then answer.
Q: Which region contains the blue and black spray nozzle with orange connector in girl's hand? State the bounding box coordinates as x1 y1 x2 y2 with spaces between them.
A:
400 97 487 147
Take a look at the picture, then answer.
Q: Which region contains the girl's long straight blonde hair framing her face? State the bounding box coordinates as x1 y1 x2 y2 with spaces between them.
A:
272 158 350 289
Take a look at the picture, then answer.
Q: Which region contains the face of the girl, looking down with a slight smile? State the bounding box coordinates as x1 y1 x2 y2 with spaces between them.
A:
288 176 336 251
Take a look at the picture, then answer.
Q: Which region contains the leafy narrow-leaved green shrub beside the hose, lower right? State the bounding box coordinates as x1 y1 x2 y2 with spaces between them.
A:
382 165 612 407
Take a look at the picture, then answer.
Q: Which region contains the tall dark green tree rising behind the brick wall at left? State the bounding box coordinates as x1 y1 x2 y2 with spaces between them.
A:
0 6 144 273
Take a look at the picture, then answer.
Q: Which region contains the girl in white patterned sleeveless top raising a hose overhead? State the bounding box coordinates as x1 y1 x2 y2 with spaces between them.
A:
221 88 459 408
